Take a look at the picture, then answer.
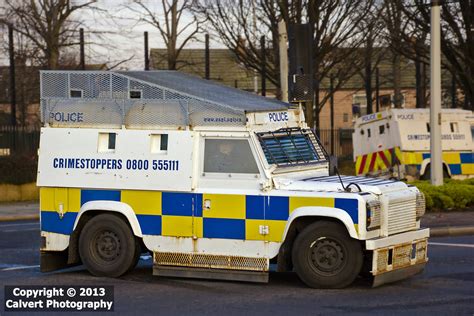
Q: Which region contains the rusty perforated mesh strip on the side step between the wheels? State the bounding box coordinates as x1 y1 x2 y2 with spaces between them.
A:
154 252 269 271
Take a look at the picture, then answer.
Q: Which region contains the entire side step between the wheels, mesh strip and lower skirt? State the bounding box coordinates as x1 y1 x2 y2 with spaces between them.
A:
153 252 270 283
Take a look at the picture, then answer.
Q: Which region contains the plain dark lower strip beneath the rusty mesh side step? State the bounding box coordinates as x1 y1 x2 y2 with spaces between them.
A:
153 265 268 283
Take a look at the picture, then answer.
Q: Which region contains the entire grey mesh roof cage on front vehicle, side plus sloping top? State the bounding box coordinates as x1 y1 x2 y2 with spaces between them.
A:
41 70 291 128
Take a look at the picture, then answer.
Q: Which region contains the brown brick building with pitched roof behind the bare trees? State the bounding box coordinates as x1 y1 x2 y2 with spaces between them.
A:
151 49 460 129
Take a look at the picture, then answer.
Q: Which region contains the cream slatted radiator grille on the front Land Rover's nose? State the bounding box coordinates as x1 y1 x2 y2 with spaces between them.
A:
388 197 416 235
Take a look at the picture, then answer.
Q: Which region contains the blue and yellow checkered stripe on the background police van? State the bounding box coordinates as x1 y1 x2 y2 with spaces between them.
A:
403 152 474 175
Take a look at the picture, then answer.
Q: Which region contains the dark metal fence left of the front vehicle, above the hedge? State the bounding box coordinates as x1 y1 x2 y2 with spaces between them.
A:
0 125 40 156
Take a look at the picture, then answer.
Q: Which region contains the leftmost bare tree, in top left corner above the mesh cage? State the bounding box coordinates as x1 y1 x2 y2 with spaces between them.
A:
0 0 96 69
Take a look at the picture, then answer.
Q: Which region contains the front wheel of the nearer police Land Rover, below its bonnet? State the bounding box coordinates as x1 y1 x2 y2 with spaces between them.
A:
292 221 363 289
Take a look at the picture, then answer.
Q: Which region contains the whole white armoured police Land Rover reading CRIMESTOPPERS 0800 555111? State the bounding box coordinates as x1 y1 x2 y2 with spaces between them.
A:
37 71 429 288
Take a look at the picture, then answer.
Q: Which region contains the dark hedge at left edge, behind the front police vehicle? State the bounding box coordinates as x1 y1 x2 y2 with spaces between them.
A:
0 155 38 184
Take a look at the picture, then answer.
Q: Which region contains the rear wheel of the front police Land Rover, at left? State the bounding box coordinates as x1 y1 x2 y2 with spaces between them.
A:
79 214 140 278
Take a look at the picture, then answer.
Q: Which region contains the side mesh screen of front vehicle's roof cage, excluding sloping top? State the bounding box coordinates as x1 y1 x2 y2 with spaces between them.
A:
41 71 252 129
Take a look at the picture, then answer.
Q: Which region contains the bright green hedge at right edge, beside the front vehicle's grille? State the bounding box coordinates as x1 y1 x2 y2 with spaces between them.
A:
412 179 474 211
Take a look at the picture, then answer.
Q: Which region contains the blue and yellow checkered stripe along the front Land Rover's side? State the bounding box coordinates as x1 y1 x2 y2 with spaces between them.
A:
40 188 358 242
